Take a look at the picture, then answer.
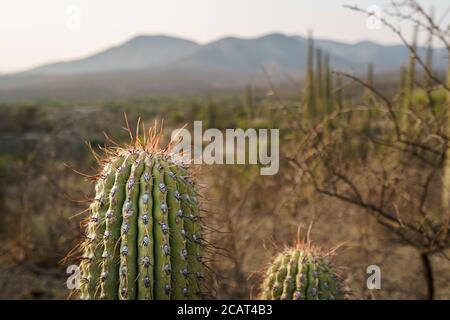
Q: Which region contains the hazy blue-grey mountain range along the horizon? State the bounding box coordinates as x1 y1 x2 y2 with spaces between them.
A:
0 33 447 100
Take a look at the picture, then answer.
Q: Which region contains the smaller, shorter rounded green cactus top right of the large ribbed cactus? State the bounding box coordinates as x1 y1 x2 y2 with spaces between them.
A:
260 235 346 300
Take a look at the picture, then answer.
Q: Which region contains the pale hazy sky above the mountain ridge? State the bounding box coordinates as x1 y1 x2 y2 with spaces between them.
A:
0 0 449 72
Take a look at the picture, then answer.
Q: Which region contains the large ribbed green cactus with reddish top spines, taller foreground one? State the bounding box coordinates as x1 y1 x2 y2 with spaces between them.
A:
80 125 205 300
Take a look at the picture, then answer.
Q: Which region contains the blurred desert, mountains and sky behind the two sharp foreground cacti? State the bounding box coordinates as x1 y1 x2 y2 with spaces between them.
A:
0 0 450 299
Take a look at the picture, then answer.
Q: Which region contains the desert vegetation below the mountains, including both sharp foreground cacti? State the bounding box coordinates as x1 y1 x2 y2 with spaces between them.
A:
0 0 450 299
